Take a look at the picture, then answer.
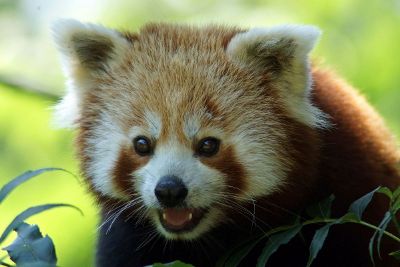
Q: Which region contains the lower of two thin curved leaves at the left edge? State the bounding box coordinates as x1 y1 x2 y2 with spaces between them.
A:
0 203 83 244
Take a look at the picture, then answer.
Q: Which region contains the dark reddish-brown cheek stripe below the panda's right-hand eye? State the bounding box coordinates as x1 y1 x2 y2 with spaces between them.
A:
200 147 247 195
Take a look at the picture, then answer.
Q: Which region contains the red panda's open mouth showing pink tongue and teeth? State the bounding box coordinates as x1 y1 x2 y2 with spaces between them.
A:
159 208 206 233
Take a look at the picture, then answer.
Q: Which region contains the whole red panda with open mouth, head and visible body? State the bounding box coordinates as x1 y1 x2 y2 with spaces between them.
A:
54 20 400 266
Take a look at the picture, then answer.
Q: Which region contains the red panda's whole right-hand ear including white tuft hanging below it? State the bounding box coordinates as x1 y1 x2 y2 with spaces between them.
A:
226 25 328 127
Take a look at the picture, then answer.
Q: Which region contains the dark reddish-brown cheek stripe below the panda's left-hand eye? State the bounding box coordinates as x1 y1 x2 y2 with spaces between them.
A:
113 147 149 196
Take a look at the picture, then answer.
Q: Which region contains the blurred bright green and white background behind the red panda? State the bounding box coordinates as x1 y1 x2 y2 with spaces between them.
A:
0 0 400 267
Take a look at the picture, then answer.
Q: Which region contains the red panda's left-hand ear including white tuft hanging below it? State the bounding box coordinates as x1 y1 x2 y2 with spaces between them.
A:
52 19 130 128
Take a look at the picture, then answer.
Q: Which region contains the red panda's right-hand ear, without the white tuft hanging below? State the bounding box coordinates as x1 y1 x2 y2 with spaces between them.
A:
227 25 320 91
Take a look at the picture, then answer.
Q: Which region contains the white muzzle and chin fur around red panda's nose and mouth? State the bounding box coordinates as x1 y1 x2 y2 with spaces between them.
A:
135 139 224 239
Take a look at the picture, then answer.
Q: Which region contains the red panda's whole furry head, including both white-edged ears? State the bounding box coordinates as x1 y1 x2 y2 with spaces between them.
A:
54 20 325 239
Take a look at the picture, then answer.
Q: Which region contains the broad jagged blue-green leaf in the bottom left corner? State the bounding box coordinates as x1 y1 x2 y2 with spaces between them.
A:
4 223 57 267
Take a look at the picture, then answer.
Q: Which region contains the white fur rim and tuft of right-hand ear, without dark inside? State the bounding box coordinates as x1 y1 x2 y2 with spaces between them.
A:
227 25 329 128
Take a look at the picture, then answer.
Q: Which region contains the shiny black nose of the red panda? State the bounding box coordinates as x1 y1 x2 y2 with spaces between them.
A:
154 176 188 207
